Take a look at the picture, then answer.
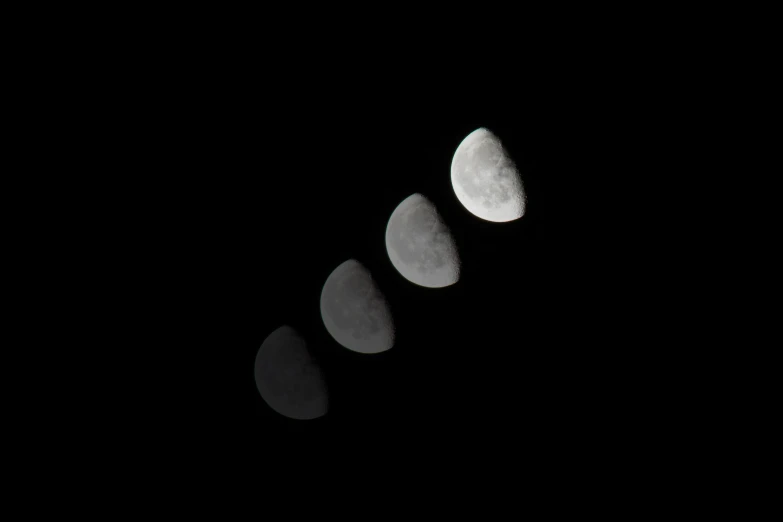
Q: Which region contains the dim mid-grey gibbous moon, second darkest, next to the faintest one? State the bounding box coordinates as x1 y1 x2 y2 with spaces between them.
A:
321 259 394 353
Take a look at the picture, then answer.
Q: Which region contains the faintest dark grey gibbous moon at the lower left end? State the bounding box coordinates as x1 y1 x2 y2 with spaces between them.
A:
255 326 329 420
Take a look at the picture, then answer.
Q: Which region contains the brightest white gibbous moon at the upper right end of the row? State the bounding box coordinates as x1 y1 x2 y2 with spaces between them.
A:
451 127 527 222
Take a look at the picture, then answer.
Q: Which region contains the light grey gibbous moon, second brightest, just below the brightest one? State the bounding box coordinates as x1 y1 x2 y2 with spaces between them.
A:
386 193 460 288
